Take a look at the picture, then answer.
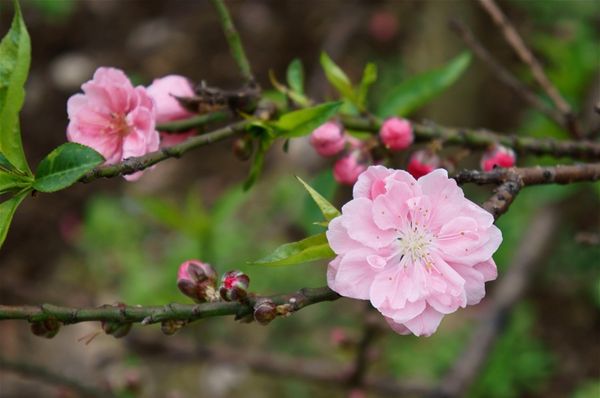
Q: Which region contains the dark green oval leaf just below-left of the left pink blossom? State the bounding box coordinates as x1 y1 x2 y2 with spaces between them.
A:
33 142 104 192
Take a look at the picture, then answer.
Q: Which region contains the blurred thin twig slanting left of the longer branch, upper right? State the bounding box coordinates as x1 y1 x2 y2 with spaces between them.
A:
450 20 564 127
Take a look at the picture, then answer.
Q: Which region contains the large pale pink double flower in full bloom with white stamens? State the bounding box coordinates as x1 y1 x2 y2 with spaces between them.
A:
327 166 502 336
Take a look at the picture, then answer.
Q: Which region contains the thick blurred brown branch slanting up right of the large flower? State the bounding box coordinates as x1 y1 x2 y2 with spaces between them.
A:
433 206 560 398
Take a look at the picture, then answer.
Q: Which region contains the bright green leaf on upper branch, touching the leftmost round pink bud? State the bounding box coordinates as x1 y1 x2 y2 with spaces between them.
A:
272 101 342 138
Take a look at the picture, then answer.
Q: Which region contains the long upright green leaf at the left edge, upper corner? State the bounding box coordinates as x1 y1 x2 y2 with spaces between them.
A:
0 1 31 175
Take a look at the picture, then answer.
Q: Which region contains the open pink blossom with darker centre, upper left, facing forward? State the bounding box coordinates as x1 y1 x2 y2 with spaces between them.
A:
67 67 159 181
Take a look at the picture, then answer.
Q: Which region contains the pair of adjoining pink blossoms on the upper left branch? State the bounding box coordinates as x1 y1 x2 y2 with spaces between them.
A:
67 67 194 181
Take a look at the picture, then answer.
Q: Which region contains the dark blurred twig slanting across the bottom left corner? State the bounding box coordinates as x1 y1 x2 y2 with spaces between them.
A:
0 358 115 398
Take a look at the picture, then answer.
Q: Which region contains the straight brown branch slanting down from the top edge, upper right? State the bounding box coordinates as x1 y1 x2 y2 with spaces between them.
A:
479 0 580 138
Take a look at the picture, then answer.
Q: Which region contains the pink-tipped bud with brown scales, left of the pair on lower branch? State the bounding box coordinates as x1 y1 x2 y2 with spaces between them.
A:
177 260 217 302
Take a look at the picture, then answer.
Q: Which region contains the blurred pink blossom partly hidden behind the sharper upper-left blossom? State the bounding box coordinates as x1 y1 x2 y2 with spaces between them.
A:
148 75 195 147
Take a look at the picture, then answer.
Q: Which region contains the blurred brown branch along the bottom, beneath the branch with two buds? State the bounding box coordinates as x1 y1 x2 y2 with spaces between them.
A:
128 337 432 396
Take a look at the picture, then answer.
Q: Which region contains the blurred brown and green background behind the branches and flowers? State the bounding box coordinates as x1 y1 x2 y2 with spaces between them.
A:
0 0 600 398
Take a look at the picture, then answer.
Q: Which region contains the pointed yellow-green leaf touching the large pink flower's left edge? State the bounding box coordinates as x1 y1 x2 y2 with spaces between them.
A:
250 233 335 266
